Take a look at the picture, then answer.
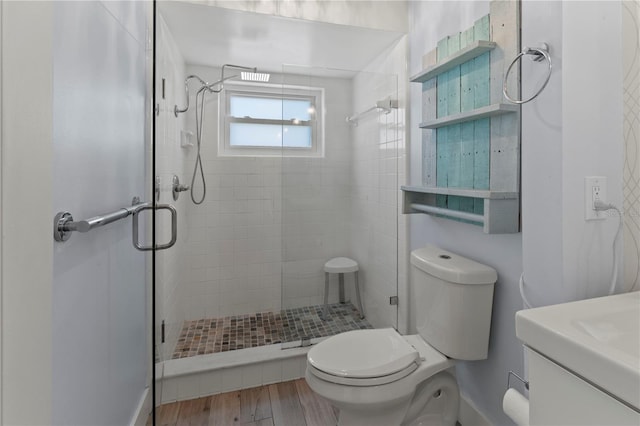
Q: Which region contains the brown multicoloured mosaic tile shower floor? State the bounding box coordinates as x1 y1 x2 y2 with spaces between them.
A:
172 303 372 359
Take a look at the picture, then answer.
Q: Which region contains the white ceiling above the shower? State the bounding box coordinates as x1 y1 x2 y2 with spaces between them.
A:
158 1 402 75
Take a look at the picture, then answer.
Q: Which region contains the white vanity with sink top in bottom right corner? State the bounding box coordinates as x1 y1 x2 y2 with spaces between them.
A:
516 292 640 426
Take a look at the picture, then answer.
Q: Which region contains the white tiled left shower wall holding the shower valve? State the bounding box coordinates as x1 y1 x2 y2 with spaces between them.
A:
155 15 191 359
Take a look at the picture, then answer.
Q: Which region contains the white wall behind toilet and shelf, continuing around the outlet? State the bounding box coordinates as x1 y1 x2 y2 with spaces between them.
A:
410 1 623 424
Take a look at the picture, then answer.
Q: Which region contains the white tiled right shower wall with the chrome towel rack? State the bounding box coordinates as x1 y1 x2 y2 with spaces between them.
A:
349 37 407 329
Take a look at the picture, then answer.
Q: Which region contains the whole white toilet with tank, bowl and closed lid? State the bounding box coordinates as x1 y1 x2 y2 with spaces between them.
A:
305 246 497 426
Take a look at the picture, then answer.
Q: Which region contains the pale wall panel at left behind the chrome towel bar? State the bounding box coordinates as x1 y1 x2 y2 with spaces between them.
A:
48 2 150 425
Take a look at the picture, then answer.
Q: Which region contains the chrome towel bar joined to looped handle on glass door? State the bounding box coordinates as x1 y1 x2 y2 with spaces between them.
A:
53 197 178 251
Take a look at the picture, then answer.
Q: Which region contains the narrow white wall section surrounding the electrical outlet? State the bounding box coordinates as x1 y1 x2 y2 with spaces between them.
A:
564 1 624 303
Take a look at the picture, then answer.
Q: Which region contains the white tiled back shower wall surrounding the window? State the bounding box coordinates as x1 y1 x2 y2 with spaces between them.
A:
180 64 351 320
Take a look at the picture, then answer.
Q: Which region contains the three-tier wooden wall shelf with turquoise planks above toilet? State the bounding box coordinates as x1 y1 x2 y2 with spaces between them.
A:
401 6 521 234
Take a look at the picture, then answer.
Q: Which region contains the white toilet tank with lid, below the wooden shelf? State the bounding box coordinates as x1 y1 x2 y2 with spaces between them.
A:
410 245 498 360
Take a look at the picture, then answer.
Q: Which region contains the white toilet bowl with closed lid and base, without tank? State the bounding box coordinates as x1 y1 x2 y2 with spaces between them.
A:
305 328 459 426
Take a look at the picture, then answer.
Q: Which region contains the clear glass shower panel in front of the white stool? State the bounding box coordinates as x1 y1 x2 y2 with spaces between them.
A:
281 65 398 348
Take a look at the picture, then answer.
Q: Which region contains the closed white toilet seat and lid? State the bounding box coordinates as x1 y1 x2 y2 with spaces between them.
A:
307 328 420 386
